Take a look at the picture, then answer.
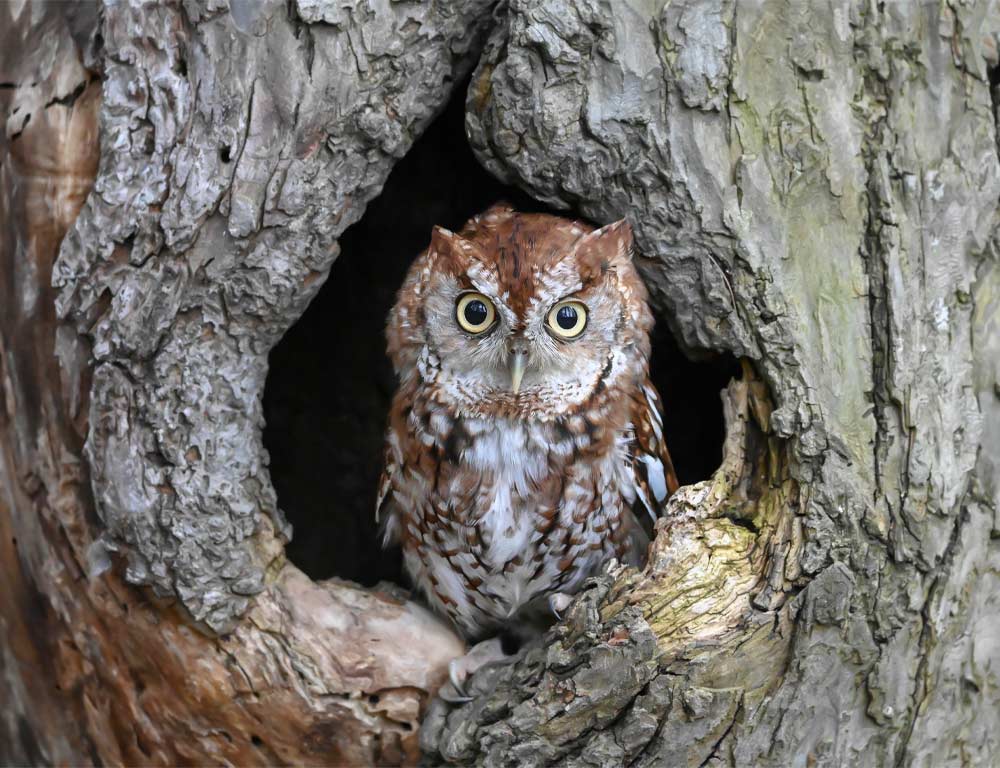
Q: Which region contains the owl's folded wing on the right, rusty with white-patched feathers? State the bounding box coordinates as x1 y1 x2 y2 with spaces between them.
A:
630 379 680 520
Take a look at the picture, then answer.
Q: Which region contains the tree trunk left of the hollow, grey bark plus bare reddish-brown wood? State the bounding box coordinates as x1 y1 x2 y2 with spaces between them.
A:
0 2 480 765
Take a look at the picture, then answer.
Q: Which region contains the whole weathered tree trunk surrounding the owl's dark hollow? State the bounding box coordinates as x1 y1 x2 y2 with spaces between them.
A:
0 0 1000 766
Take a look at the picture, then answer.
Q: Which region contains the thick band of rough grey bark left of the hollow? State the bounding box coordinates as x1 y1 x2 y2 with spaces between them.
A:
54 0 490 631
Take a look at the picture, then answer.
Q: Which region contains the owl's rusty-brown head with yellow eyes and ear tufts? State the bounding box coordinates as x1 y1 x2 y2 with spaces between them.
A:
387 205 652 419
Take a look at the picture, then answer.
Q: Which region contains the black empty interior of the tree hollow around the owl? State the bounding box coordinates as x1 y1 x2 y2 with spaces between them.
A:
264 88 736 586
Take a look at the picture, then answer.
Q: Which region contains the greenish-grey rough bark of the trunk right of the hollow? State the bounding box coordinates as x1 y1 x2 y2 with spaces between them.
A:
423 0 1000 766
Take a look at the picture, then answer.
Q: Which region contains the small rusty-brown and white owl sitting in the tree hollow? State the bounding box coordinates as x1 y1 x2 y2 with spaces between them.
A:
378 205 677 638
